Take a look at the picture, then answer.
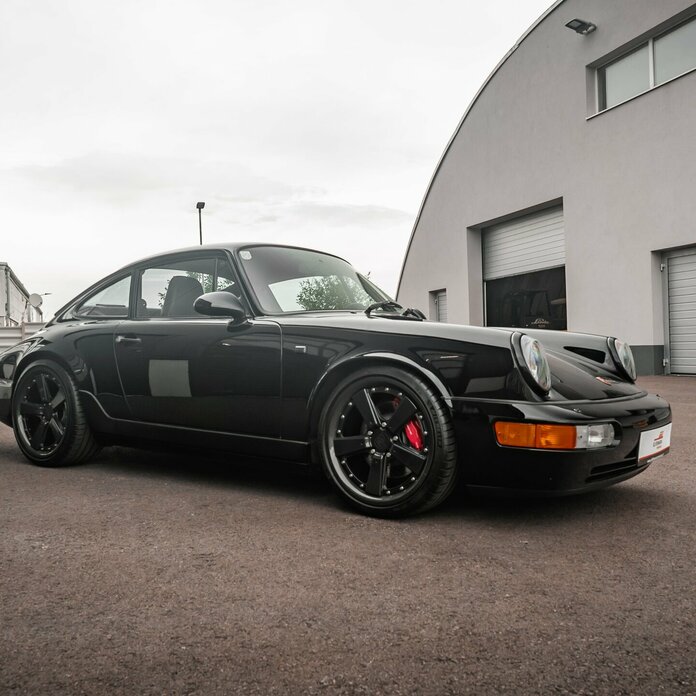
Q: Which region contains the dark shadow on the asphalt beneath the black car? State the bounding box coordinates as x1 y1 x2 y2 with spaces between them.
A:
89 447 674 523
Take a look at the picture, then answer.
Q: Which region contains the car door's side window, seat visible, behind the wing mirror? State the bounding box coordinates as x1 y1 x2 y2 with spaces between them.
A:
136 257 241 319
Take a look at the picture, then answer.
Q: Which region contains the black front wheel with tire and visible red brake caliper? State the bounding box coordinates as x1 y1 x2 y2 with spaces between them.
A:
318 366 457 517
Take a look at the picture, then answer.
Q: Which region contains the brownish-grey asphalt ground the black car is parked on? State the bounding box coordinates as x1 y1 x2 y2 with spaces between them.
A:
0 377 696 695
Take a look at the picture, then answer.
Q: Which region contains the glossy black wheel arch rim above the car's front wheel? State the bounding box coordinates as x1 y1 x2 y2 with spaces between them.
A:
308 352 452 441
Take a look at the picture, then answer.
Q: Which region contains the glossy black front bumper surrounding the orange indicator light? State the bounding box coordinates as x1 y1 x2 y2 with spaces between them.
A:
452 394 672 495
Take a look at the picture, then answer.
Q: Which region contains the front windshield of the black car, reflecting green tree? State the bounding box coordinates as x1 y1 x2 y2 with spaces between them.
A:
239 246 389 314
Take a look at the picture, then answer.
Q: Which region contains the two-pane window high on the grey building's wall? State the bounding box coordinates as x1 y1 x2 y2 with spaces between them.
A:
597 14 696 111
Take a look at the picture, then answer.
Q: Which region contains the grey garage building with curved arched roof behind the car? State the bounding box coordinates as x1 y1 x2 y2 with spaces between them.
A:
397 0 696 374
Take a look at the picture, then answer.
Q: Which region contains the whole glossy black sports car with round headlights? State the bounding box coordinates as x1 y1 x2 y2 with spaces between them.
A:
0 244 671 516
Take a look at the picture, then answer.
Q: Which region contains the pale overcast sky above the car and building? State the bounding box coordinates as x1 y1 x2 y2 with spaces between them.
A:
0 0 551 318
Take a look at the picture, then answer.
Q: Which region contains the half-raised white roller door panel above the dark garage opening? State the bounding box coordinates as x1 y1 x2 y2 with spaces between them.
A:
483 207 565 280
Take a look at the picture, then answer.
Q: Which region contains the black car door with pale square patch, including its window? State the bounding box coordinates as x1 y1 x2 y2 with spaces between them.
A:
114 251 281 437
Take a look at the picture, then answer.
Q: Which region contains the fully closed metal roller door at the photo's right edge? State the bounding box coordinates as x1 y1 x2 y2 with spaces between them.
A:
667 251 696 375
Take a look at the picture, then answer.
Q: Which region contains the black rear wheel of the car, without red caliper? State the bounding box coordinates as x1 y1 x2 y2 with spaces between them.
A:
12 360 99 466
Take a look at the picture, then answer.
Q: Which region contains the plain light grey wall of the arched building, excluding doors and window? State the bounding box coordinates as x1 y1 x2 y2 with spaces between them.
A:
398 0 696 354
